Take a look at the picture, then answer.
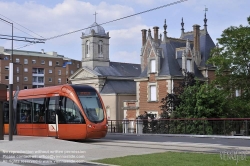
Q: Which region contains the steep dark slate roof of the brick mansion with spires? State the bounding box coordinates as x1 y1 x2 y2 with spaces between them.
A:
139 30 215 78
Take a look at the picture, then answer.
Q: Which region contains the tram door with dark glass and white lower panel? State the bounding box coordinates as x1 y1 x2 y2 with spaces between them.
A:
46 96 60 137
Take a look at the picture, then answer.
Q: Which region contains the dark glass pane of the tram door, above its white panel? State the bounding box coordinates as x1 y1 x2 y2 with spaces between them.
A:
47 97 59 123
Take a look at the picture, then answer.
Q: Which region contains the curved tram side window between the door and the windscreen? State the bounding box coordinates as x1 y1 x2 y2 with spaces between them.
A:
58 96 85 123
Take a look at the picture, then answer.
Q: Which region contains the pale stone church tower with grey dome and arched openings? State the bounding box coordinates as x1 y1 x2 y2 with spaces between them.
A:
81 22 110 69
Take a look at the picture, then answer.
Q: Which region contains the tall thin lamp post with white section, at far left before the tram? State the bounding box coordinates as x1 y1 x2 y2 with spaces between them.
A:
0 18 13 141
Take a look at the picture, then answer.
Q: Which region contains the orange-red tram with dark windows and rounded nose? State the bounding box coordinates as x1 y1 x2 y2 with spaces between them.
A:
3 84 108 140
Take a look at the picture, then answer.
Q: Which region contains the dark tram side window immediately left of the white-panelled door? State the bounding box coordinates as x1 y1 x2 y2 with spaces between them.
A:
32 98 46 123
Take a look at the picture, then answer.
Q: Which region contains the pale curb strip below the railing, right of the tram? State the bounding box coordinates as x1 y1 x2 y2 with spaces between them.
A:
108 133 250 140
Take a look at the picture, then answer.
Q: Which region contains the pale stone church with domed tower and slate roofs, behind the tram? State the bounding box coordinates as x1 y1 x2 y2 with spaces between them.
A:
69 22 141 120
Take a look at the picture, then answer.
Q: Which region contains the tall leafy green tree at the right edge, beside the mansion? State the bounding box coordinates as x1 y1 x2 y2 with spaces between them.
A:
208 17 250 117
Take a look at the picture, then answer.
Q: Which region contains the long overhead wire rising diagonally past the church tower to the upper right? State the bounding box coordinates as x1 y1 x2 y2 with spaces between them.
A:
13 0 188 49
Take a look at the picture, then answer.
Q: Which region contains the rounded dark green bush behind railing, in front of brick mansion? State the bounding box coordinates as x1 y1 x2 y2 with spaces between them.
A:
173 83 229 118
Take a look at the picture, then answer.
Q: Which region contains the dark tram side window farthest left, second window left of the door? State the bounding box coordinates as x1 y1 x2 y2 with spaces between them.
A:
17 100 32 123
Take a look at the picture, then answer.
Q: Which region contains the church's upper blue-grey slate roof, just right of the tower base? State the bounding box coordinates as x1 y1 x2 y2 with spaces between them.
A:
94 62 141 77
